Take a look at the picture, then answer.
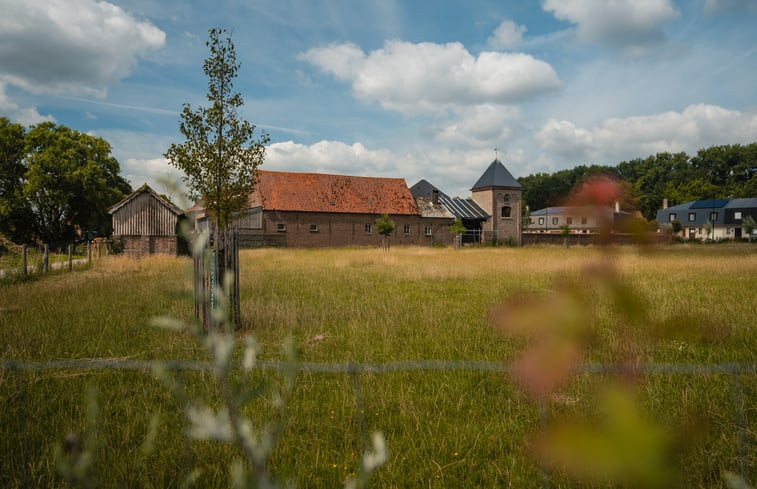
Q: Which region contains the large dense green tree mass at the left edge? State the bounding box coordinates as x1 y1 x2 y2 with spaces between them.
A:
0 117 132 246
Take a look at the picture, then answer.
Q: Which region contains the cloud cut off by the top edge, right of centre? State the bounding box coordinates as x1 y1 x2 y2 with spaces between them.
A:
542 0 679 50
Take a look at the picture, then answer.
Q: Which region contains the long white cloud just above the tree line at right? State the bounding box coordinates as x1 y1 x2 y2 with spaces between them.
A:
535 104 757 164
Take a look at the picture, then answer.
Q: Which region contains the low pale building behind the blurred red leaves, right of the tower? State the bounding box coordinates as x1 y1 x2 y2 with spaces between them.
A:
525 203 635 234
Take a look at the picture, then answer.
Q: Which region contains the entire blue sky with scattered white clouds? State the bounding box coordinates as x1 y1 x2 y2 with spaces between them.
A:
0 0 757 200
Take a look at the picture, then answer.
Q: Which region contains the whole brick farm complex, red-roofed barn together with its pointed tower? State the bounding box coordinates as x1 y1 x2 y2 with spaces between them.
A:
187 160 521 248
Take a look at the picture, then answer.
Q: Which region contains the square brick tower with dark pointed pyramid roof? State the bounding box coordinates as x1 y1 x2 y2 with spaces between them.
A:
471 158 523 244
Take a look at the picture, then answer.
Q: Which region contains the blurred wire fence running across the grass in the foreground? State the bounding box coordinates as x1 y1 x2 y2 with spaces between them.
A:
0 358 757 487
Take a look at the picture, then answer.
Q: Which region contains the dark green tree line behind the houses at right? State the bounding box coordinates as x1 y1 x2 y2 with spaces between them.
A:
518 143 757 220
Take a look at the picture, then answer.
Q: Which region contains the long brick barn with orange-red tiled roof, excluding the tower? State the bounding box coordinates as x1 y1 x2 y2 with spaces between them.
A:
233 170 453 248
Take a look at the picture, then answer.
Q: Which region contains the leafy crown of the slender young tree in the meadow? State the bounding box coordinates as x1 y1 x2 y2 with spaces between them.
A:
164 28 269 231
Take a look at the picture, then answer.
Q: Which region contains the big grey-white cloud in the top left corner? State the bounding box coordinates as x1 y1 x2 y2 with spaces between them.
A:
0 0 165 96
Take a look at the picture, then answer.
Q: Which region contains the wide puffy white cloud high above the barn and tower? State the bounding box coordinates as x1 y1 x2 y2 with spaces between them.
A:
300 41 560 114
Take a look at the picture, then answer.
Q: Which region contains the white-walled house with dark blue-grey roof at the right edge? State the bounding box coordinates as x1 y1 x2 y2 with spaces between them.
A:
657 198 757 240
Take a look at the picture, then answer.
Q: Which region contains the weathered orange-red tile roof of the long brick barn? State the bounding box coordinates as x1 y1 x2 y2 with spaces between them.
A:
249 170 419 215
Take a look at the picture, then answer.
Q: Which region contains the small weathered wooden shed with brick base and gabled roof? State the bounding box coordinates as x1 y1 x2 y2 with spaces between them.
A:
108 184 184 256
